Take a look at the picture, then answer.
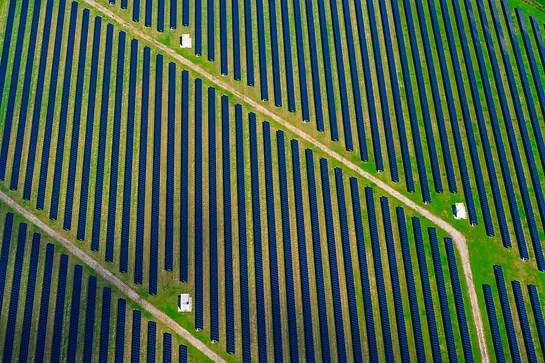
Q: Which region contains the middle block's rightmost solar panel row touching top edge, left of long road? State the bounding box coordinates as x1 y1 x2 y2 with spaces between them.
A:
49 2 78 220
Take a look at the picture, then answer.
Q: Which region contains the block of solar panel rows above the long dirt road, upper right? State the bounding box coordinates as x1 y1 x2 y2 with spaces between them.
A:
99 0 545 270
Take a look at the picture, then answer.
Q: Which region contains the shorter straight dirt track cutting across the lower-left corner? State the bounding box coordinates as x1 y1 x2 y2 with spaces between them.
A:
0 191 225 362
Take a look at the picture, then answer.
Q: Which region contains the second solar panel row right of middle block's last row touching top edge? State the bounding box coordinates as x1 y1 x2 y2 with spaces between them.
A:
76 17 102 241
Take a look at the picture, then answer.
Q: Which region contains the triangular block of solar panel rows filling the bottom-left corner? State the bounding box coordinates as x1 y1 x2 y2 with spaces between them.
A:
0 211 198 362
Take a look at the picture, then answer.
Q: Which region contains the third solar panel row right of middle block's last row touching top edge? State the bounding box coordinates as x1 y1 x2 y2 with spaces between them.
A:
91 24 114 251
